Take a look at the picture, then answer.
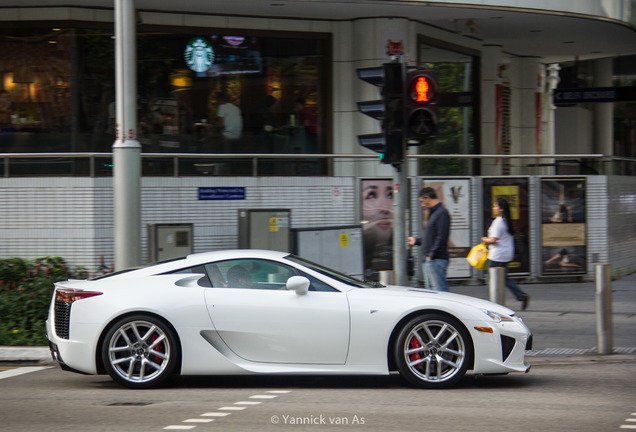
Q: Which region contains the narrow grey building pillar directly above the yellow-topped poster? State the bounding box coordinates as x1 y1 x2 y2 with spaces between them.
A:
480 45 503 175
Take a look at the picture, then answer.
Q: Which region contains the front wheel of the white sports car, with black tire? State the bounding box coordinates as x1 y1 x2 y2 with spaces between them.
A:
394 313 474 389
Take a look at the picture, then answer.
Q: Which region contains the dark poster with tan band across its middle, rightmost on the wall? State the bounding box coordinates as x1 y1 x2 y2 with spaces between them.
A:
541 178 587 275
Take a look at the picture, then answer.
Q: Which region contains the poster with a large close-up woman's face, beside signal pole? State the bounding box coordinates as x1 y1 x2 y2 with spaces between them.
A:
360 179 393 277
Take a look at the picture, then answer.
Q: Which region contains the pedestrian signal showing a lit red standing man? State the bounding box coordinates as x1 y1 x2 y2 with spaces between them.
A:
406 69 439 145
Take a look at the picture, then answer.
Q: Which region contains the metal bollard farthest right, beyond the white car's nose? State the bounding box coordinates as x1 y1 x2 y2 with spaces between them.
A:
596 264 614 354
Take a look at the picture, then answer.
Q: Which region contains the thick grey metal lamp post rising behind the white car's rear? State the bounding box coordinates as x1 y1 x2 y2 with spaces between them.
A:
113 0 141 270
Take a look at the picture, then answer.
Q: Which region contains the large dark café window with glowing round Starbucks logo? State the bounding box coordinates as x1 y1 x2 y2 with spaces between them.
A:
0 28 330 175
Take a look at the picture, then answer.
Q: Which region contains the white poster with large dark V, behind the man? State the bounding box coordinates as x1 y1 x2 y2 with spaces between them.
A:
417 179 472 279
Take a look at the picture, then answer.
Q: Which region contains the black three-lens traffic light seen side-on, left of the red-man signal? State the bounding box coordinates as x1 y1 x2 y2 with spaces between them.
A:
357 63 406 165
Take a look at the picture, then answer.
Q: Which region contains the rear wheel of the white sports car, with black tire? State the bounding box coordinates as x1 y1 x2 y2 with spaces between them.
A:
101 315 180 389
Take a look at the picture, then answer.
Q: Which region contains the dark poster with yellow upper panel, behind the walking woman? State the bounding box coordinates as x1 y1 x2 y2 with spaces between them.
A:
480 177 530 274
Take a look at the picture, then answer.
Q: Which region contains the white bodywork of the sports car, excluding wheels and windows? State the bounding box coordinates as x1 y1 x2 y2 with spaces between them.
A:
47 250 531 386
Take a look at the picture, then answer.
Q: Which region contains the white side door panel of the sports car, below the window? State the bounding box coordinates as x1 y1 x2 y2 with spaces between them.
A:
205 288 349 364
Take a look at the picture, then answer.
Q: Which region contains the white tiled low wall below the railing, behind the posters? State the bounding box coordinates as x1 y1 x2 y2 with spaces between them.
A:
0 176 636 280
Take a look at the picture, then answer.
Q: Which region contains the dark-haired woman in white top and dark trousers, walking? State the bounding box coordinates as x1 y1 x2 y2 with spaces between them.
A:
481 198 530 310
